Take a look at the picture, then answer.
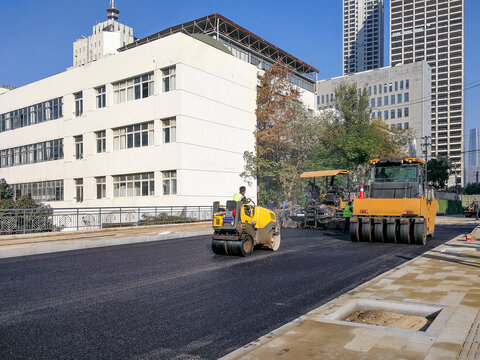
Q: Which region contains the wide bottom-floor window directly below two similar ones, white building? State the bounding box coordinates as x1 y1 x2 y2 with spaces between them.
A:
113 172 155 197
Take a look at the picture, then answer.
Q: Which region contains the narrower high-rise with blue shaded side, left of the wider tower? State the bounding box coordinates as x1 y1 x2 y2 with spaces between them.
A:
342 0 383 75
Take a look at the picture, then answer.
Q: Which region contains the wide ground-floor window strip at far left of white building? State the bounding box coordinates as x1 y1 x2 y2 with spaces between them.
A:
12 180 63 202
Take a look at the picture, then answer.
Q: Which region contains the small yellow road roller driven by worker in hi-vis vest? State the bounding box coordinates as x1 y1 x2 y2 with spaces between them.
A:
212 199 280 256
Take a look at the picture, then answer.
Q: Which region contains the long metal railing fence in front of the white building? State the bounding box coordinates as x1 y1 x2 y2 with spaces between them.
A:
0 206 213 235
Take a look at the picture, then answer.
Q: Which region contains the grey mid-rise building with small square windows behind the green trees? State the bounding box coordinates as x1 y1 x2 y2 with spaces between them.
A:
317 61 431 157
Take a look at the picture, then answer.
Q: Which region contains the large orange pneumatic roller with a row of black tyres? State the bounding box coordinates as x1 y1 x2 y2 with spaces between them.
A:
350 157 438 245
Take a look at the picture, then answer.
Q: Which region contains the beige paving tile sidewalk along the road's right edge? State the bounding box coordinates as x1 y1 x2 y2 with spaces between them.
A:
223 224 480 360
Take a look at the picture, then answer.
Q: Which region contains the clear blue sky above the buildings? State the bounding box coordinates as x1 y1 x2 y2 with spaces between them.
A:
0 0 480 129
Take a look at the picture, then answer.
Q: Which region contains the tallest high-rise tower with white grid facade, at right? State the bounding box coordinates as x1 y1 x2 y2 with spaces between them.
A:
390 0 465 185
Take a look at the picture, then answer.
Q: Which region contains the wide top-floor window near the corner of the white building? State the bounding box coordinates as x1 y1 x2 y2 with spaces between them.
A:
113 73 153 104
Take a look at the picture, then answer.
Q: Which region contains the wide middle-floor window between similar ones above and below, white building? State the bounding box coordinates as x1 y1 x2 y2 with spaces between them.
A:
113 121 153 150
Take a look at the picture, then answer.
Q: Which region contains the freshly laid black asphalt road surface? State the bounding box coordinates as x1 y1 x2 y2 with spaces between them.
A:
0 225 473 359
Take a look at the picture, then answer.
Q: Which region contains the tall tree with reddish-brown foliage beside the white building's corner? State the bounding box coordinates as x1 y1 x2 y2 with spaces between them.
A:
242 60 320 203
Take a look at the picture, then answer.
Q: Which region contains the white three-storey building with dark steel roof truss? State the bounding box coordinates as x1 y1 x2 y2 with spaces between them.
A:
0 14 315 207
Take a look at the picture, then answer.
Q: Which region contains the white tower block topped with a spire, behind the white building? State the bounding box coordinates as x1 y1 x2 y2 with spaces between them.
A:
73 0 135 67
